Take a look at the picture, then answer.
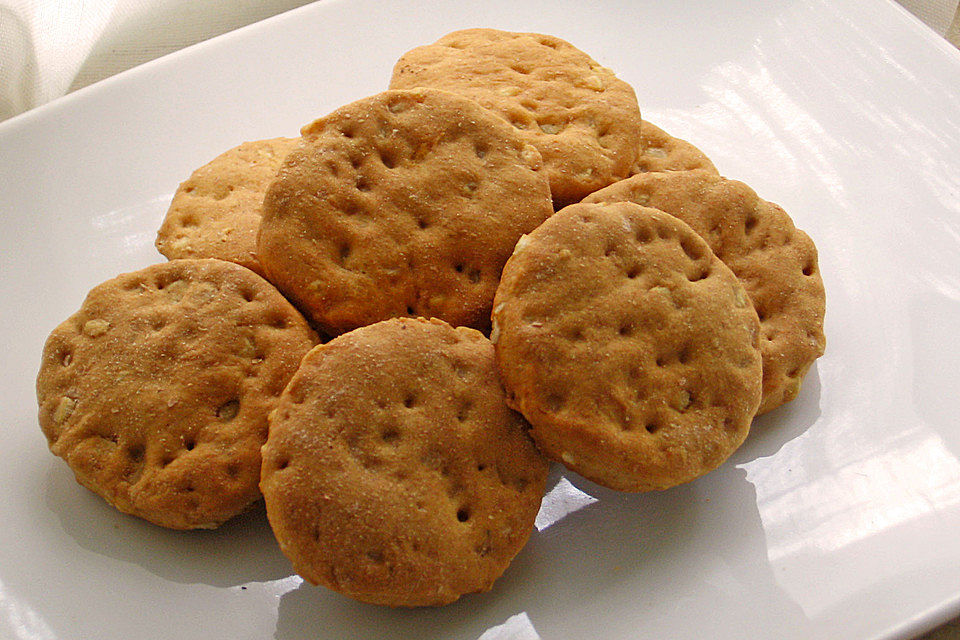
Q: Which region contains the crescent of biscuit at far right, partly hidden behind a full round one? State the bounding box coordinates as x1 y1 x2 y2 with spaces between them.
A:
586 171 826 413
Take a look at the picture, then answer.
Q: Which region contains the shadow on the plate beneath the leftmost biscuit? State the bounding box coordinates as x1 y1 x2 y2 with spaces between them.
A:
43 461 291 587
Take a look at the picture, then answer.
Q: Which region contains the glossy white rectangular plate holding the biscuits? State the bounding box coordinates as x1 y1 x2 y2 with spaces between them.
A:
0 0 960 640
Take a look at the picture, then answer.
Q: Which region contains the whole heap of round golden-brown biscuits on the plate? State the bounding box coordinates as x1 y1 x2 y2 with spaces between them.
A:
37 29 824 606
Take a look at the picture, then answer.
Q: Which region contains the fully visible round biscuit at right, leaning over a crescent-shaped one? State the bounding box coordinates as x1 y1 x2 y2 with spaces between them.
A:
491 203 761 491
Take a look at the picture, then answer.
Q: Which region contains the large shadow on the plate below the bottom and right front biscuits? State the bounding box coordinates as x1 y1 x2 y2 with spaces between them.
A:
274 465 807 640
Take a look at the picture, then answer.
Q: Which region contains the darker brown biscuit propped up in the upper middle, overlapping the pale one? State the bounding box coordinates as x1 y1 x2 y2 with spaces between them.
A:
258 89 553 335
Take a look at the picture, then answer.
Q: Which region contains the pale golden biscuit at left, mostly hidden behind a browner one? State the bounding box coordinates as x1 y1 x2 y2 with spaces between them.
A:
156 138 299 275
